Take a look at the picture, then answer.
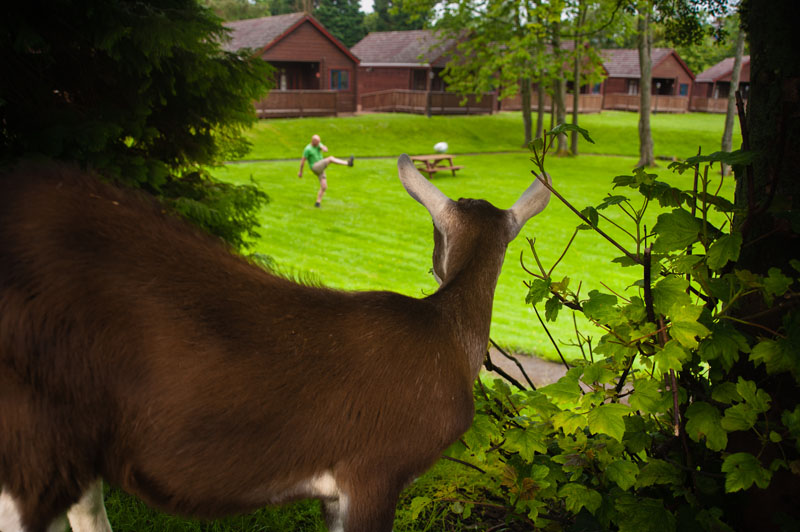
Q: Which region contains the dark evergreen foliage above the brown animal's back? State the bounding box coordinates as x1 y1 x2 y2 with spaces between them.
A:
0 0 271 249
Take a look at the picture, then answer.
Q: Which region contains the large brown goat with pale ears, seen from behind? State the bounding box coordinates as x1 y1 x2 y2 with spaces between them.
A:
0 155 550 532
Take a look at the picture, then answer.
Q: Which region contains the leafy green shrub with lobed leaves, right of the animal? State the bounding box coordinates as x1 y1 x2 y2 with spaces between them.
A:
410 126 800 532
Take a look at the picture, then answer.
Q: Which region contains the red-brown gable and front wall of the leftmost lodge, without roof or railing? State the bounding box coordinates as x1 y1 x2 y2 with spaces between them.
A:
261 21 358 113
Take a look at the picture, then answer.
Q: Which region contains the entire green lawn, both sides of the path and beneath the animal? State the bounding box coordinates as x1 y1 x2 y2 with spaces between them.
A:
100 112 736 532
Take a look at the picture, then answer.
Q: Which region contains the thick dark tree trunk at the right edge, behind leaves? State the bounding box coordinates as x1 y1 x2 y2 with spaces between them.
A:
726 0 800 530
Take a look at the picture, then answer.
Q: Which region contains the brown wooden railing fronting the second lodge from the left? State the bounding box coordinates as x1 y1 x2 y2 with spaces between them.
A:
361 89 493 115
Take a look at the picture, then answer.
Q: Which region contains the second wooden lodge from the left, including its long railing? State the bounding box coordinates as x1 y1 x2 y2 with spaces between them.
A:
352 30 493 115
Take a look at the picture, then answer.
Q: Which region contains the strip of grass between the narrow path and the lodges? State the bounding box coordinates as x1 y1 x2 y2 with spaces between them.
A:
241 111 741 160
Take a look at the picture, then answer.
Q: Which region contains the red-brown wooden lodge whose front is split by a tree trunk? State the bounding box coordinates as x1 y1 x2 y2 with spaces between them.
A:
602 48 694 113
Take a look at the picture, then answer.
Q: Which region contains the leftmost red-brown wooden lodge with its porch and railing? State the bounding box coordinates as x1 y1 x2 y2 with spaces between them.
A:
219 13 358 118
